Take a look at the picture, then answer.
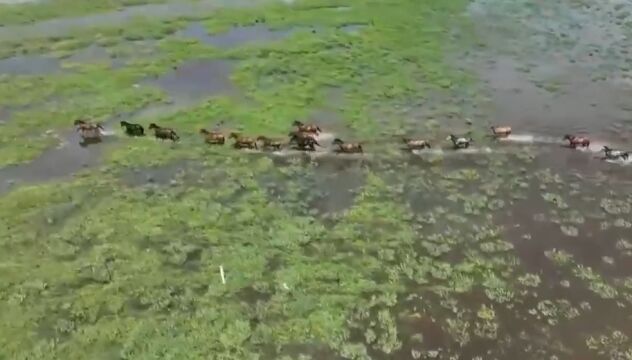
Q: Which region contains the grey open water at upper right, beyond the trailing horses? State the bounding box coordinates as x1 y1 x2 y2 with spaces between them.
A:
470 0 632 143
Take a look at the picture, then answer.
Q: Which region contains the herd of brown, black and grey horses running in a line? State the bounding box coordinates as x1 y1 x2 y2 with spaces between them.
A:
74 120 630 160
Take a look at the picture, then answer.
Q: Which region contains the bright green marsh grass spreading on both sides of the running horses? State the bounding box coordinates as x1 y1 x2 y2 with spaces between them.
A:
0 0 632 359
